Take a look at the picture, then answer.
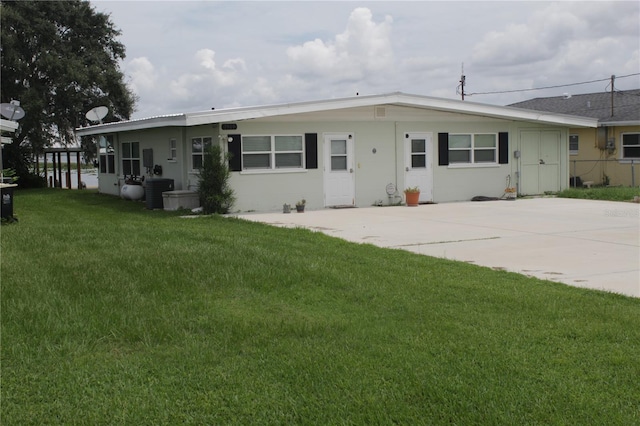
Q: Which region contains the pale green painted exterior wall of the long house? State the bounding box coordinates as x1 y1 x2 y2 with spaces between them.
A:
100 106 569 212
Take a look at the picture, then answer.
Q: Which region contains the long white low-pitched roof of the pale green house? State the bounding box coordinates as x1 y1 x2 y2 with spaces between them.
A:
76 92 597 136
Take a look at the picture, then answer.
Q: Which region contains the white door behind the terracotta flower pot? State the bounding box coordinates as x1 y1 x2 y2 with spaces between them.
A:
402 133 433 202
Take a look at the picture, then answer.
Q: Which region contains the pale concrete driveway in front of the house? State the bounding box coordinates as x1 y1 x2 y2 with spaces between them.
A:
232 198 640 297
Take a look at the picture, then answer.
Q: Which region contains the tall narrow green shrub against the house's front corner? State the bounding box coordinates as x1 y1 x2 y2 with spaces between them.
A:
198 144 235 214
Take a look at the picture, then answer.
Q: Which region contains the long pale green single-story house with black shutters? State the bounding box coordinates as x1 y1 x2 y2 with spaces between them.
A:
77 93 597 212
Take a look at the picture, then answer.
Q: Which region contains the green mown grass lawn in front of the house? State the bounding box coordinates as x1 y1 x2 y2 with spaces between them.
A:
0 189 640 426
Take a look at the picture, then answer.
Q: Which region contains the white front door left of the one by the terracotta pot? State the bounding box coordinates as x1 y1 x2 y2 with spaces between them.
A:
324 134 355 207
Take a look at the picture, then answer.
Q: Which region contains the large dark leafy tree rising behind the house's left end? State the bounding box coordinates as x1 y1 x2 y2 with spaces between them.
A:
0 0 135 184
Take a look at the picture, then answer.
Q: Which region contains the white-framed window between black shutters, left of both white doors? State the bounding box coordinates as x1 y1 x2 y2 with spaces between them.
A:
242 135 304 170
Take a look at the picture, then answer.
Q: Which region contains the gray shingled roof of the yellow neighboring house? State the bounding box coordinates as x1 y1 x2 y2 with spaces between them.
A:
509 89 640 125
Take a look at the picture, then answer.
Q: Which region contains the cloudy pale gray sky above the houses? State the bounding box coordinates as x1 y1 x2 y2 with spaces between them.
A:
91 0 640 118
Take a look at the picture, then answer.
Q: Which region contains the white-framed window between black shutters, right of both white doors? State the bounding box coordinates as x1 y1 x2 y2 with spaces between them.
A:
449 133 498 164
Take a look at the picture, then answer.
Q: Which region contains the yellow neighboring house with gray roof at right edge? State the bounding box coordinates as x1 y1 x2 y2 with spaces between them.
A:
510 89 640 186
